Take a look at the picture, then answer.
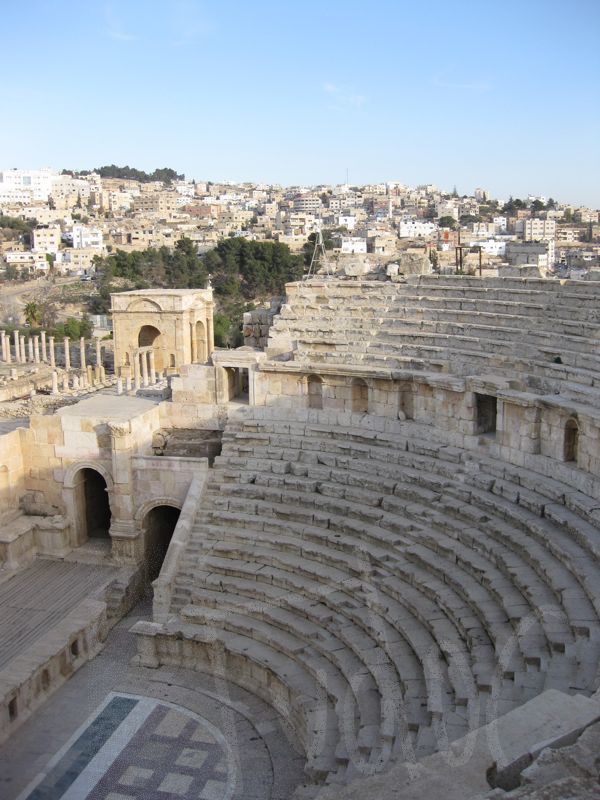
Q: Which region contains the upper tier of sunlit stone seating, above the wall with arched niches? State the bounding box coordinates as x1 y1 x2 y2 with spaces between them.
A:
270 275 600 404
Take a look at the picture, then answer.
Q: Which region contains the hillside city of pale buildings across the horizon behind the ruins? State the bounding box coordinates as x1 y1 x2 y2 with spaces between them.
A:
0 166 600 279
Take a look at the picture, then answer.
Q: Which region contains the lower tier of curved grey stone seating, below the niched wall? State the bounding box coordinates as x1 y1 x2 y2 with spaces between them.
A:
172 408 600 782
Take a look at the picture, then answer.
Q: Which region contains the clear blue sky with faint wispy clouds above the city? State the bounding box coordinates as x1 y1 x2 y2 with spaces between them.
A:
0 0 600 207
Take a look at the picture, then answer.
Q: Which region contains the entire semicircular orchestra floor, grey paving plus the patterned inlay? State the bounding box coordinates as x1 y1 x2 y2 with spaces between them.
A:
0 606 305 800
